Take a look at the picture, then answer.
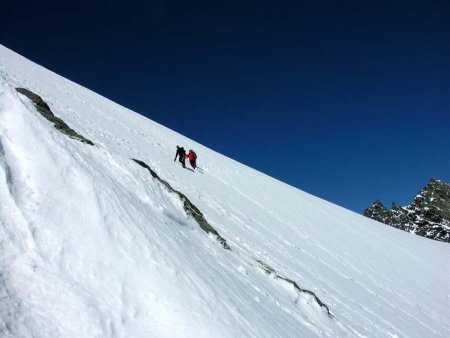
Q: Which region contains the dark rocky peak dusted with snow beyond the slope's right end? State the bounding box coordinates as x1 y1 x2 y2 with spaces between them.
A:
364 179 450 242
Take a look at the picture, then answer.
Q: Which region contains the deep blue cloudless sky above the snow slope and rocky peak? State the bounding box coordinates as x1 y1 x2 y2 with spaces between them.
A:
0 0 450 212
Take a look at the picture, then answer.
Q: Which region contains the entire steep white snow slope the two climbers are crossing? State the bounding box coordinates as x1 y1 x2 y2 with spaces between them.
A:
0 46 450 337
